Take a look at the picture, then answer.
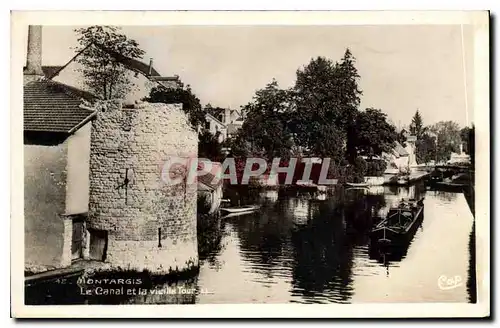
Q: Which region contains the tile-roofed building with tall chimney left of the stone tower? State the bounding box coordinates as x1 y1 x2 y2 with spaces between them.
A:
23 26 96 272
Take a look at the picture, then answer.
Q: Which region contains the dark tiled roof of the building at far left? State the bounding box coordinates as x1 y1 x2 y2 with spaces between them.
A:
23 78 96 133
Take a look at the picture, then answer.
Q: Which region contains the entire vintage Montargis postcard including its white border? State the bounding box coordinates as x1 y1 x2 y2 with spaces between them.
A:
11 11 491 318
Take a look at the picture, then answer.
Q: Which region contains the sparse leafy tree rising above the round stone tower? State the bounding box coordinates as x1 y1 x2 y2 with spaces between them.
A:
75 26 144 99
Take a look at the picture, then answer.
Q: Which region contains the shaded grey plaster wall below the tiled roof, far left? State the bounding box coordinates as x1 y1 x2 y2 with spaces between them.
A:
24 141 71 272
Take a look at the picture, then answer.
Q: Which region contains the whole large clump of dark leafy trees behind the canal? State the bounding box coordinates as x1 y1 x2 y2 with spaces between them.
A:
228 49 398 180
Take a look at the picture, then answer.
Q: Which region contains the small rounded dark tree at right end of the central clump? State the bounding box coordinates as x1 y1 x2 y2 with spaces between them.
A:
351 108 398 157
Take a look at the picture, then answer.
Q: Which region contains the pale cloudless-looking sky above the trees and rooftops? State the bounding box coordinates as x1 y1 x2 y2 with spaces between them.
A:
30 25 474 126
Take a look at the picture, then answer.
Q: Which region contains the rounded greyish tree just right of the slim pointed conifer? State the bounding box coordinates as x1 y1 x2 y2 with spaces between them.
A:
430 121 462 161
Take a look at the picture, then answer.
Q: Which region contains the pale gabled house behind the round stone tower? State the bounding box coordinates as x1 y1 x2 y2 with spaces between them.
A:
43 43 182 102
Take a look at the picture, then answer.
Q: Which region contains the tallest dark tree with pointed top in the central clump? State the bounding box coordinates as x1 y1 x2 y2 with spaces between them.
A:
291 49 362 162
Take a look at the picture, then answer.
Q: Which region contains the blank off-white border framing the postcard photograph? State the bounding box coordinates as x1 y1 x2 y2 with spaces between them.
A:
11 11 490 318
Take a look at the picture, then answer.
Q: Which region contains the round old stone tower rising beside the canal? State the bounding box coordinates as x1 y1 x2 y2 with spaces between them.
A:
87 102 198 273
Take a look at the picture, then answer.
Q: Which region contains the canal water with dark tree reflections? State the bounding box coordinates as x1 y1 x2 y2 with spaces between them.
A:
26 184 475 304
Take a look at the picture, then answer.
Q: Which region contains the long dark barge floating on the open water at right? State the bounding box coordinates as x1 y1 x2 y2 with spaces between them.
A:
370 199 424 246
